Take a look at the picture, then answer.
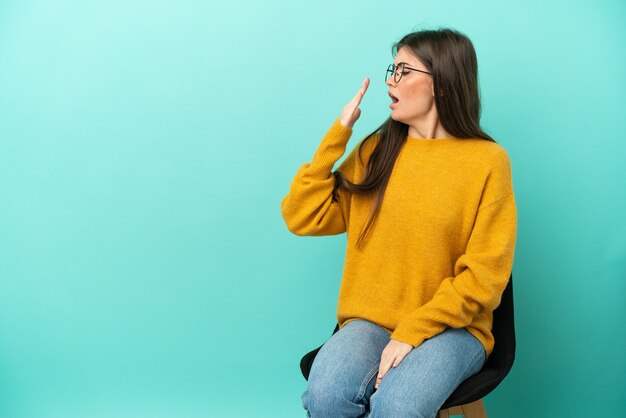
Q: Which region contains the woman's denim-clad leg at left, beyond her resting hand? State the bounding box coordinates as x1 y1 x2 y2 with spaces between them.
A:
302 319 389 418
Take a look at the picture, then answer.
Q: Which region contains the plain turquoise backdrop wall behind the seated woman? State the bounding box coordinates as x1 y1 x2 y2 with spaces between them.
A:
0 0 626 418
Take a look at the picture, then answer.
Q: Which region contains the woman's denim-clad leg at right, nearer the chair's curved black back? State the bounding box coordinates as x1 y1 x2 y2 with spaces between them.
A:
369 328 485 418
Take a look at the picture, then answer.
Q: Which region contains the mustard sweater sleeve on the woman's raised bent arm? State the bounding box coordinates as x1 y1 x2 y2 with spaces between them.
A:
281 119 358 235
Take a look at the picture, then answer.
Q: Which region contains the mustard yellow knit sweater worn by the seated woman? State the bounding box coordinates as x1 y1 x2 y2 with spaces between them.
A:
281 119 517 357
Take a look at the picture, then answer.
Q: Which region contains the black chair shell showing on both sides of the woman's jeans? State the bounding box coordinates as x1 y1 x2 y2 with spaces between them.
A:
300 273 515 409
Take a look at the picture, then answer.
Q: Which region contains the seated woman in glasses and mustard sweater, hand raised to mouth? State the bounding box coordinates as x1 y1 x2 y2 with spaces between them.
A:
281 29 517 418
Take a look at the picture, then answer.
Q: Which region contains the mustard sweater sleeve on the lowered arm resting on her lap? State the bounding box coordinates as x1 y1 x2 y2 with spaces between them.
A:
391 154 517 347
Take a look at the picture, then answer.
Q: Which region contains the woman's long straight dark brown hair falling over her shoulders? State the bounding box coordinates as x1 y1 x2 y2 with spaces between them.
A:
333 28 496 247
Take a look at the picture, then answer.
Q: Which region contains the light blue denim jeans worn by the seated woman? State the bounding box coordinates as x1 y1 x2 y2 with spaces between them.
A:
302 319 485 418
